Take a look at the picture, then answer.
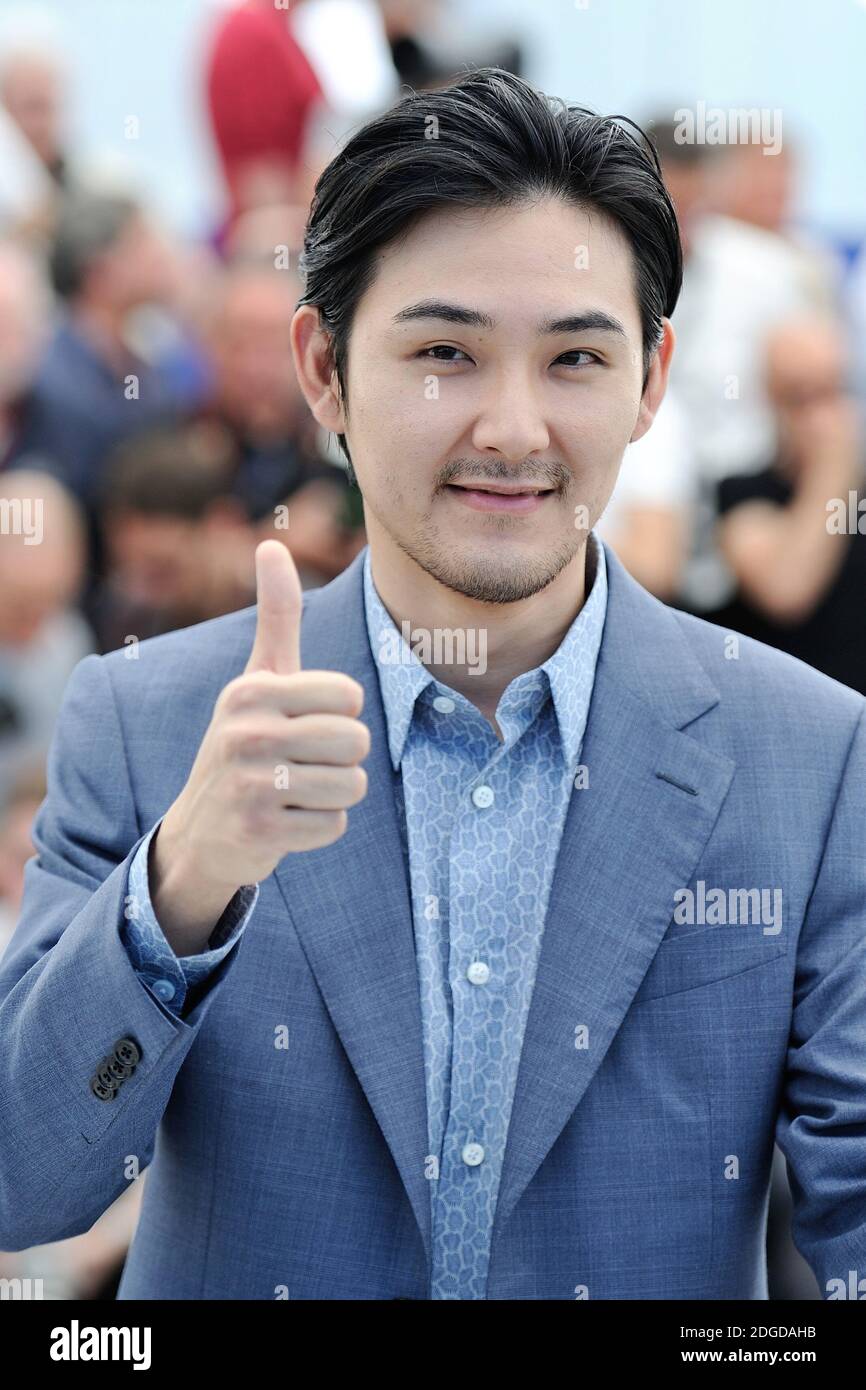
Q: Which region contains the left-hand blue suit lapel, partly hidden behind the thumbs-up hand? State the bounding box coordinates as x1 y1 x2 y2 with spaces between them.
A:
275 552 431 1259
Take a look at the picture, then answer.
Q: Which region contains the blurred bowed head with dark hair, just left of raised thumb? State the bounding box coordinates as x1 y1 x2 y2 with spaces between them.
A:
92 424 256 652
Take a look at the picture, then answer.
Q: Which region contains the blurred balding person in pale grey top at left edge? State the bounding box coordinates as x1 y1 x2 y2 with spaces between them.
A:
0 468 93 805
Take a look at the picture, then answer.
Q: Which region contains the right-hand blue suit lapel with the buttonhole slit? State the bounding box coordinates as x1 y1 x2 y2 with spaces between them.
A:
496 548 734 1234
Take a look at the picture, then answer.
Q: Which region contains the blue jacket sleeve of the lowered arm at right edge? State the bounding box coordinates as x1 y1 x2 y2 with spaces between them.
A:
776 705 866 1298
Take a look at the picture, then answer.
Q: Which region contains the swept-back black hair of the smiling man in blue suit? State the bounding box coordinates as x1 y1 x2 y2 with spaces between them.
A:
297 67 683 477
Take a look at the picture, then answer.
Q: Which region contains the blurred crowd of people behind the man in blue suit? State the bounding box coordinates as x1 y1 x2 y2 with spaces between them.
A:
0 0 866 1297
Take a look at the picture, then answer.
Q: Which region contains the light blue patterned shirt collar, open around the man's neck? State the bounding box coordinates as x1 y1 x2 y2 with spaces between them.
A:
364 531 607 771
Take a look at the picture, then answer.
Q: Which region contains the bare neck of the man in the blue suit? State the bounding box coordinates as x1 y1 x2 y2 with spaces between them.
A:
370 534 595 723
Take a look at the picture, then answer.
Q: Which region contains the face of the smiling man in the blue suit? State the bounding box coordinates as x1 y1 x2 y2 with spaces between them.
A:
335 199 667 603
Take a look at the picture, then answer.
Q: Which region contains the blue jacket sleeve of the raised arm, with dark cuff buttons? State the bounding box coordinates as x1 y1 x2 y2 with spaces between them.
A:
0 656 248 1251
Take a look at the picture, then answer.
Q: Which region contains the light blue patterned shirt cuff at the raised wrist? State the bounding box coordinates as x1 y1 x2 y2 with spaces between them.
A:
121 817 259 1017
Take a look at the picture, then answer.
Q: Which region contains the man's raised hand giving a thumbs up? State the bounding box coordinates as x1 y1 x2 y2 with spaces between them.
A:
149 541 370 955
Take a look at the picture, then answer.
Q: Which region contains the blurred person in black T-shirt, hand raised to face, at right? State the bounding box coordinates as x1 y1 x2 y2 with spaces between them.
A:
717 318 866 694
